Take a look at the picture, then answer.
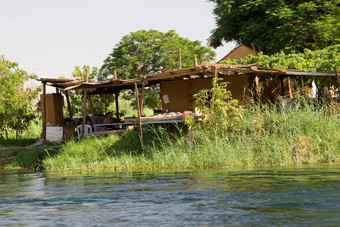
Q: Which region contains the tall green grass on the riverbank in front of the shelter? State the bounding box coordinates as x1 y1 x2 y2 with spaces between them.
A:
42 102 340 172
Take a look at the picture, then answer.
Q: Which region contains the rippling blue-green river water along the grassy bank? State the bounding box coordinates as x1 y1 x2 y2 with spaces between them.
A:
0 165 340 226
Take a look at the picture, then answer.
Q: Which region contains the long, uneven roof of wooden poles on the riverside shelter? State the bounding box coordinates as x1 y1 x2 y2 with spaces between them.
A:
38 63 336 94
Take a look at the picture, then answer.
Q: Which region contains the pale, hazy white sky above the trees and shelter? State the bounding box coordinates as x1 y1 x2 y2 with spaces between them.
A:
0 0 235 78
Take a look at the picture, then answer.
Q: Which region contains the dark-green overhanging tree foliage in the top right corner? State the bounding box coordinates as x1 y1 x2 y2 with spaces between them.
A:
210 0 340 54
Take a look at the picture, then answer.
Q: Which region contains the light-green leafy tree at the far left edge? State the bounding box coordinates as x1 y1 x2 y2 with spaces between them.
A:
0 56 40 137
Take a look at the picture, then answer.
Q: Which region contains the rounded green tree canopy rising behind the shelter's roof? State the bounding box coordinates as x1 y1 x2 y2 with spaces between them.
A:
100 30 215 79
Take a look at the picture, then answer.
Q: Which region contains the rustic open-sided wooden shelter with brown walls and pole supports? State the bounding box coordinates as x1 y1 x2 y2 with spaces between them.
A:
38 63 337 144
